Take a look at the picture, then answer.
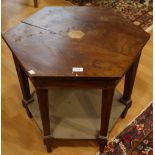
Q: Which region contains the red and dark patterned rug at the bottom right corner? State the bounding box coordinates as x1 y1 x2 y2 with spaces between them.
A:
101 104 153 155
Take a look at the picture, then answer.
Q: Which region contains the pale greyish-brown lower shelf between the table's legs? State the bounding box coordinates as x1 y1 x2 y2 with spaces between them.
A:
28 88 125 139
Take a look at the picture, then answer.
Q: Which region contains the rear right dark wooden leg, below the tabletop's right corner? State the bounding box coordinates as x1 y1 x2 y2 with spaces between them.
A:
120 56 140 118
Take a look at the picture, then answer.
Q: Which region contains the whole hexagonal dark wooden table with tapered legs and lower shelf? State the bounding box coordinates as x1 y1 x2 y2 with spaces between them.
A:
3 7 149 154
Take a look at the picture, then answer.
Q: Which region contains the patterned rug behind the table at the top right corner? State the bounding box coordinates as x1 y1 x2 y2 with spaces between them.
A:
71 0 153 31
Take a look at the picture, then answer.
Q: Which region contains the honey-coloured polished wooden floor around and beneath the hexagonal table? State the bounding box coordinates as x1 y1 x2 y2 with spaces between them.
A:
2 0 152 155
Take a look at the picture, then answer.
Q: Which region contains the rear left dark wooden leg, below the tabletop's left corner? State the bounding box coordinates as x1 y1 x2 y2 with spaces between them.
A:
13 56 33 118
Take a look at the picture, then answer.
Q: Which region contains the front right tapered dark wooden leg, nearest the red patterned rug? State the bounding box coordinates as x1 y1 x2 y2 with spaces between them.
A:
98 89 114 155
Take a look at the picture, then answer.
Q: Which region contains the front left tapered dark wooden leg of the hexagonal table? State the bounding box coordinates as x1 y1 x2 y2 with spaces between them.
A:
36 89 52 152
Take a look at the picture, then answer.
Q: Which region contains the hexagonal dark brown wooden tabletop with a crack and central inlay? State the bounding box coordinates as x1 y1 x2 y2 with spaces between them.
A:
4 7 149 79
